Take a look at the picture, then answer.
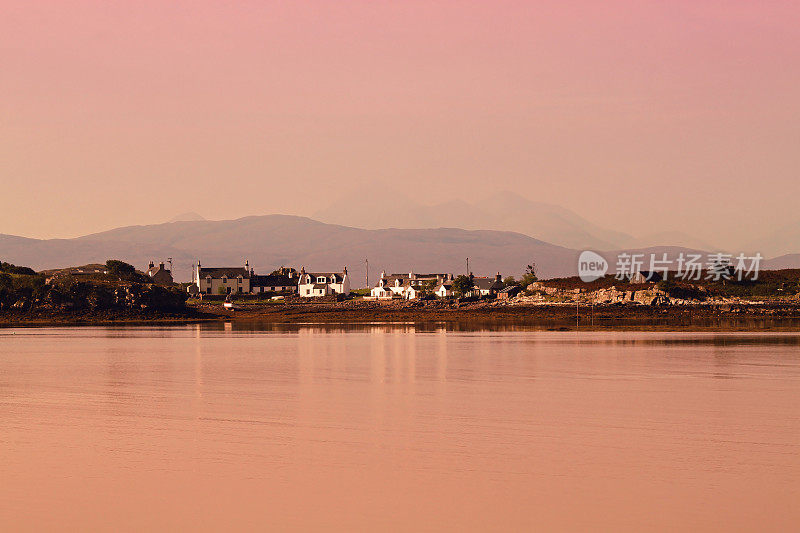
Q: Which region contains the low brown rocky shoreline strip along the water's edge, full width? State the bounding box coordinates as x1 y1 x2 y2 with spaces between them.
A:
0 297 800 331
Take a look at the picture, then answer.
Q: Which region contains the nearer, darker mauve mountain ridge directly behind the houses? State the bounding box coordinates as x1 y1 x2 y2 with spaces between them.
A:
0 215 800 287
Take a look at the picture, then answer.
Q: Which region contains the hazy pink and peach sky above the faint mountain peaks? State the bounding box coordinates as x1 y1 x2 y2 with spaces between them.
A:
0 1 800 245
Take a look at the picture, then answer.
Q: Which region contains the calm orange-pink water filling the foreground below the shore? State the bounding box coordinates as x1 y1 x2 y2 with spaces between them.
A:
0 326 800 531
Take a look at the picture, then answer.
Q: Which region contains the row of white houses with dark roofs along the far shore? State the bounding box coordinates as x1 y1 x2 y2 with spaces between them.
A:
189 261 503 300
